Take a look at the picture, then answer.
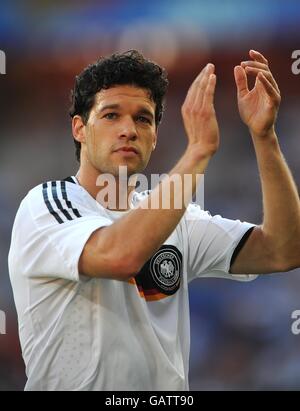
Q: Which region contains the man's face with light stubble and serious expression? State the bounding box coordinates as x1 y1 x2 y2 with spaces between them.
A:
76 85 156 176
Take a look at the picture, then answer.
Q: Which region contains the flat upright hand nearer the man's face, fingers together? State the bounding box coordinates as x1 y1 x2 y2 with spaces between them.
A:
181 64 219 158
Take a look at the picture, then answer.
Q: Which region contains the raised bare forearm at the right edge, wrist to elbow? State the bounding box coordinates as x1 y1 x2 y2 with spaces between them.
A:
252 130 300 265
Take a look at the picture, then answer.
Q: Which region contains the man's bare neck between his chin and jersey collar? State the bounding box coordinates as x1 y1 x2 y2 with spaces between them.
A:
76 166 135 211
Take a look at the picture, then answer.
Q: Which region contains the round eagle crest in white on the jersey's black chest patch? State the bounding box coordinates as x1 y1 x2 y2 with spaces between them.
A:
149 245 182 295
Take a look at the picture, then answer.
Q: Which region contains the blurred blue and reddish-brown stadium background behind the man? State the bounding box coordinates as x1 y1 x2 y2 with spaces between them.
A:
0 0 300 390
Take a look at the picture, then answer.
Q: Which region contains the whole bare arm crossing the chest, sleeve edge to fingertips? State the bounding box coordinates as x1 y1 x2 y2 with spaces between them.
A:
79 64 219 280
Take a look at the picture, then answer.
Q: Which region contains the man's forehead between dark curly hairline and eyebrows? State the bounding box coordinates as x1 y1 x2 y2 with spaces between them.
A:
95 85 155 110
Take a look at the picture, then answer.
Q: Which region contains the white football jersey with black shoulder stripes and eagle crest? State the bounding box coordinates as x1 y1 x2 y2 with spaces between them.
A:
9 177 255 391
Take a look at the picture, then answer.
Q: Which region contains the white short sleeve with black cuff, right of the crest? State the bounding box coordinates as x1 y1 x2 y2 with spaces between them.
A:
182 204 257 281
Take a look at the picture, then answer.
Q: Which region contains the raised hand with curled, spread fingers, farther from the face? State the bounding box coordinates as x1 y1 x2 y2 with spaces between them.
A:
234 50 280 137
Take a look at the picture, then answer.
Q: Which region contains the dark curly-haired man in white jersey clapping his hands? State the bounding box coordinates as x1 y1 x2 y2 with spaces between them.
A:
9 50 300 390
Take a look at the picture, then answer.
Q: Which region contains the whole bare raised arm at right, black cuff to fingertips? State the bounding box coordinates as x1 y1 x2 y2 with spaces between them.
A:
230 50 300 274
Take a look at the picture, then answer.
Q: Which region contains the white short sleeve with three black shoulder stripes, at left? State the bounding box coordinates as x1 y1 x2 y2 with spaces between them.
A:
9 182 112 281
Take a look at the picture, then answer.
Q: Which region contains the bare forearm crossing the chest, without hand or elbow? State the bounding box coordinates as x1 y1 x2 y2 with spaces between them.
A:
97 147 210 274
